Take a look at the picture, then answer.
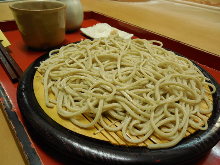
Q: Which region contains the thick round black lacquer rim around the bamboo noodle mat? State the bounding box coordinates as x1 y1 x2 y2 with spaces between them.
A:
17 49 220 165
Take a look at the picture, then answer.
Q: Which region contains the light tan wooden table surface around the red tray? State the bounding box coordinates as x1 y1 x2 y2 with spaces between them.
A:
0 0 220 165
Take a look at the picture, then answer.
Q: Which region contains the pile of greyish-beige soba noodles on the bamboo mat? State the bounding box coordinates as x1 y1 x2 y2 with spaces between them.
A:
38 35 215 149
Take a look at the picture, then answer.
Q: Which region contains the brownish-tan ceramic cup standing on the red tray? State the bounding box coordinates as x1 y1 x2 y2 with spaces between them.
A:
9 0 66 49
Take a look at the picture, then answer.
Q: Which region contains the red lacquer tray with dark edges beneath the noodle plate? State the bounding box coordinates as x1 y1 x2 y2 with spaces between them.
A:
0 12 220 165
